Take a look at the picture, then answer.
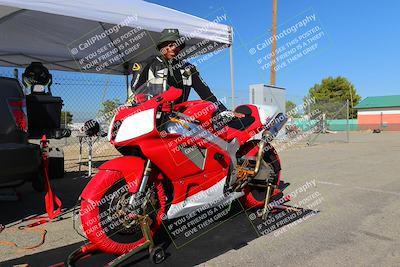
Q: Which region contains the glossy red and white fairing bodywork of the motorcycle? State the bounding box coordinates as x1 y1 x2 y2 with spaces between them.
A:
103 88 282 219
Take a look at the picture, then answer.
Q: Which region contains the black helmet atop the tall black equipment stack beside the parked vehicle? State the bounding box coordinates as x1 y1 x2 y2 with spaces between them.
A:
22 62 52 86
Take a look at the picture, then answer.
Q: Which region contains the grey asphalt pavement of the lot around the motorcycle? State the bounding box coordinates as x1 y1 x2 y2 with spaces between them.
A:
0 132 400 266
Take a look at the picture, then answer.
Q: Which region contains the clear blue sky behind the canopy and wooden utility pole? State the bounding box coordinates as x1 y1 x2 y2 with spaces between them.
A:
0 0 400 121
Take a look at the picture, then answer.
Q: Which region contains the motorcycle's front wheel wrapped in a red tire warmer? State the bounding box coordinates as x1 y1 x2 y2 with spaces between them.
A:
80 171 166 254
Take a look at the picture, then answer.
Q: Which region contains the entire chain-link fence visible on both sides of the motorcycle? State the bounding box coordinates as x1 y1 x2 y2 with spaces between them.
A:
0 68 398 171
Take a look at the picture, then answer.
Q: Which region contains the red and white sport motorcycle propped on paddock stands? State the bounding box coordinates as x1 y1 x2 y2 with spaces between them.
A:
80 81 286 260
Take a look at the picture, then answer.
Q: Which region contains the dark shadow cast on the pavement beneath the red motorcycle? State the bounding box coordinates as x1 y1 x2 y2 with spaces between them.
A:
0 202 317 266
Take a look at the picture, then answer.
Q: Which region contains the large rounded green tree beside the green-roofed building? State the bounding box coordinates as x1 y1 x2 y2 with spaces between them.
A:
305 76 361 119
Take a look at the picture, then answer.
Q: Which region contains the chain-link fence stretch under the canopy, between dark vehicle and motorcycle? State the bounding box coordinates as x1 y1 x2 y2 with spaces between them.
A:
0 68 127 172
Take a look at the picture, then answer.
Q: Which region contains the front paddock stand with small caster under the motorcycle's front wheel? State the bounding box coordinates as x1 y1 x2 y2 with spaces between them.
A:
65 215 165 267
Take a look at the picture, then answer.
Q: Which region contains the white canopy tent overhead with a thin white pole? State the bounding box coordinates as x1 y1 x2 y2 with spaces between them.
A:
0 0 234 107
